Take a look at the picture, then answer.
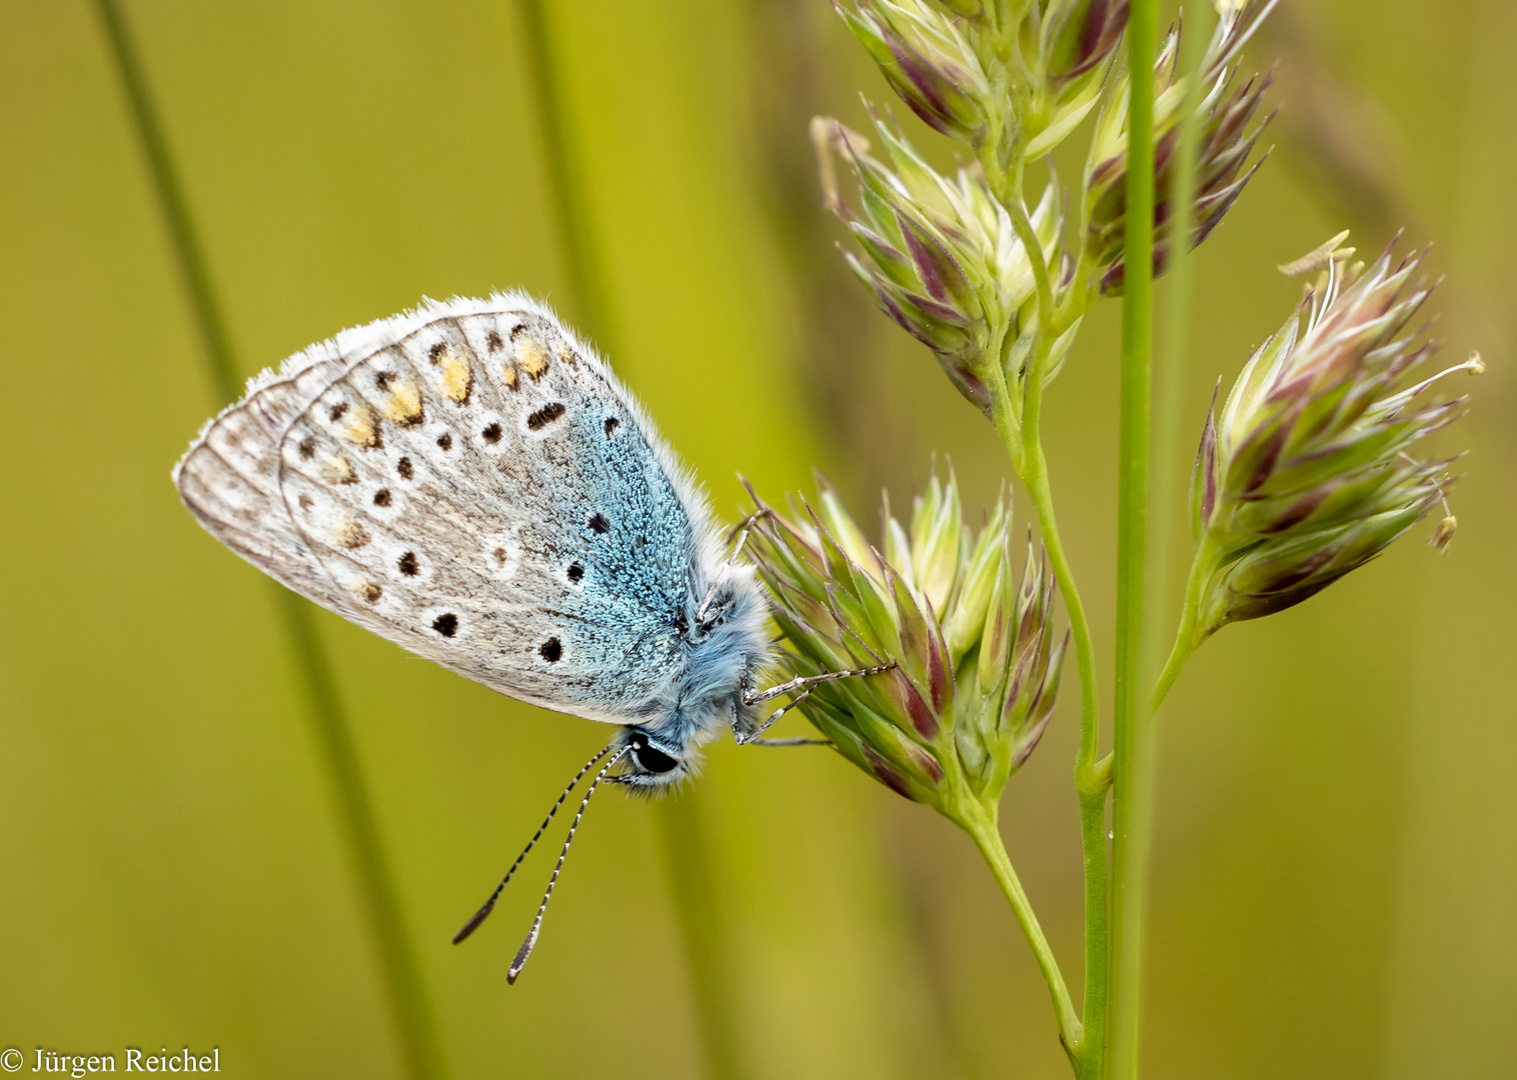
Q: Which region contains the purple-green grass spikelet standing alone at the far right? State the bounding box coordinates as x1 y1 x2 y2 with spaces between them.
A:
1191 237 1481 634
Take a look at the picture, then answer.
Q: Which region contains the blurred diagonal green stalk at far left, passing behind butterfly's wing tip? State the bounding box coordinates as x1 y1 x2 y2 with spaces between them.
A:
96 0 448 1080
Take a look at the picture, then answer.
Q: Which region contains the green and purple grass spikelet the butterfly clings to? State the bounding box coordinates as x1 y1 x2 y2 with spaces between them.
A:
752 475 1065 818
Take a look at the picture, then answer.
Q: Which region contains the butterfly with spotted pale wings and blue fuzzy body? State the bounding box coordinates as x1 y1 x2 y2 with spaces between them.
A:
173 293 883 981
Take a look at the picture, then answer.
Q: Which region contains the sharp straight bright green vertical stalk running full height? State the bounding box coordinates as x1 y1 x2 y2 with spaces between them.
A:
1107 0 1157 1080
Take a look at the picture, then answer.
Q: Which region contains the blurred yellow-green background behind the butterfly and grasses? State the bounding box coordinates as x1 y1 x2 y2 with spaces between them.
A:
0 0 1517 1080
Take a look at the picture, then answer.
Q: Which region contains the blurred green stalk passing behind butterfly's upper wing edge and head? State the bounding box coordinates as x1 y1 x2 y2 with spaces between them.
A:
517 0 748 1080
